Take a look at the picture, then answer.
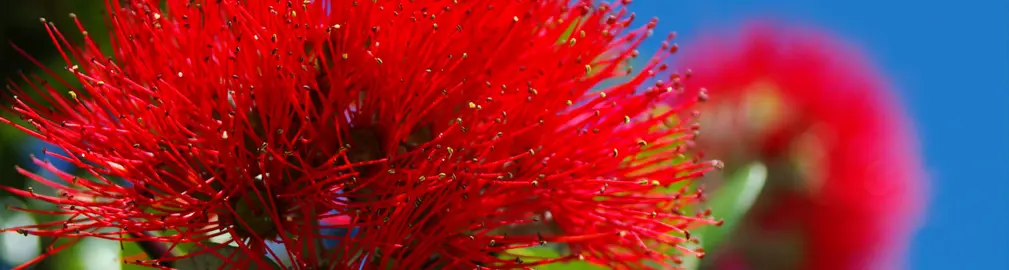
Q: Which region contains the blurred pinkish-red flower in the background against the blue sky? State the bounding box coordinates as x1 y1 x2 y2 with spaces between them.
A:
684 22 922 269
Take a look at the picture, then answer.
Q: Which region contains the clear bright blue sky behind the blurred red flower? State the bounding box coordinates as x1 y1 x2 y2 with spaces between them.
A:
632 0 1009 269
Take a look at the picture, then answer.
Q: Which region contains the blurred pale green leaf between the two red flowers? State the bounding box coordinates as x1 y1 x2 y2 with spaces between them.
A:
684 162 767 269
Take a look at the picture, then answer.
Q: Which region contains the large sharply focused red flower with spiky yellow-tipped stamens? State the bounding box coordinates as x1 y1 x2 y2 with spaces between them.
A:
2 0 717 269
